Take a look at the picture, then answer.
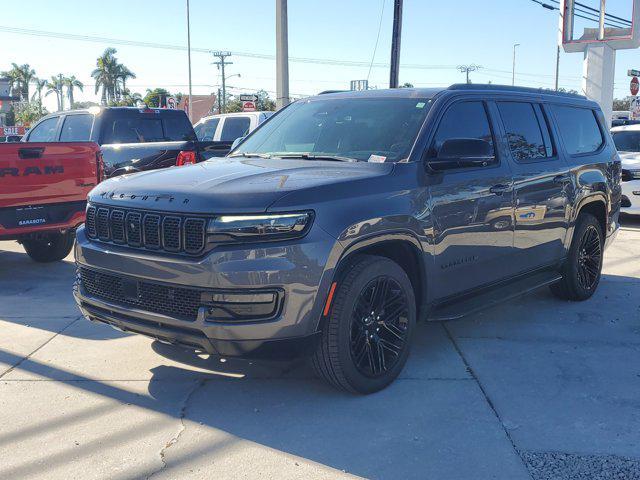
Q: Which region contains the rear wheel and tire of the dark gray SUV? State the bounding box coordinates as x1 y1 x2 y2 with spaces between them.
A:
550 213 604 301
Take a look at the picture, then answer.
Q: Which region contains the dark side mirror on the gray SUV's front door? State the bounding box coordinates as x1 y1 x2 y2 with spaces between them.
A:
428 138 496 170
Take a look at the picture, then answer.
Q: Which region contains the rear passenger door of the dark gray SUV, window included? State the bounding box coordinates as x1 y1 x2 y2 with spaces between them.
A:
496 99 571 273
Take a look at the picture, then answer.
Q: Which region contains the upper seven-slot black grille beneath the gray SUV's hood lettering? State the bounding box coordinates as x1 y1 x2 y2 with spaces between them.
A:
86 205 207 255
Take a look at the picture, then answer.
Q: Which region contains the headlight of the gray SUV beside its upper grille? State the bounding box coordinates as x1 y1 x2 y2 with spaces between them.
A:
207 212 312 242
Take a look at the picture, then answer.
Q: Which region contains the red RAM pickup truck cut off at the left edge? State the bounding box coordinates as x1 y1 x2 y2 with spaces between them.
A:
0 142 103 262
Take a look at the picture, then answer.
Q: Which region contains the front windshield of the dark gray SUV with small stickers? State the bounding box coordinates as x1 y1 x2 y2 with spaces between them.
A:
232 97 430 162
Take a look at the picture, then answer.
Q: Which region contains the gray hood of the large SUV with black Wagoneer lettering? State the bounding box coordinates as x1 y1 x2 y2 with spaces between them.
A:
89 158 393 213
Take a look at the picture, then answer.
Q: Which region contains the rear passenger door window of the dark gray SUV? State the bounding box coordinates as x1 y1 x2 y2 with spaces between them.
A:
498 102 553 160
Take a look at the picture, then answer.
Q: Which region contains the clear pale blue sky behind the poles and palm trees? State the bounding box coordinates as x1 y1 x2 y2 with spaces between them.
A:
0 0 640 110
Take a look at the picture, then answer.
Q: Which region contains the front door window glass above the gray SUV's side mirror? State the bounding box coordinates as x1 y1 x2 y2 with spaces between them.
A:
430 102 493 156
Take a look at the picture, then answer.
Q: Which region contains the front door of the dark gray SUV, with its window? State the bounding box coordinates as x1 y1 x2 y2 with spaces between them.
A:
427 100 514 299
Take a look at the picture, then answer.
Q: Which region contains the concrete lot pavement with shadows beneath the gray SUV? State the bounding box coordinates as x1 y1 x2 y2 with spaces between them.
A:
0 218 640 480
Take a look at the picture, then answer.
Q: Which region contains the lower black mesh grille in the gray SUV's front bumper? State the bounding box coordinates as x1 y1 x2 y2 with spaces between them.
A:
79 268 202 321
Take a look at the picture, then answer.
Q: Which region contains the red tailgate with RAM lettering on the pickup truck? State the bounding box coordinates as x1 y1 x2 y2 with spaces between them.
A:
0 142 99 209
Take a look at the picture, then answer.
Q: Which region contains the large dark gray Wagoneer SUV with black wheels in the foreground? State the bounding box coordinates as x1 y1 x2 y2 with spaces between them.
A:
75 85 621 393
